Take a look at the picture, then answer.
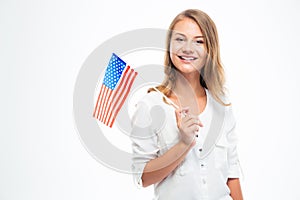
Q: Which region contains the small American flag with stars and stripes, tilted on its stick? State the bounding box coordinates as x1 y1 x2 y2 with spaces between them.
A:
93 53 137 127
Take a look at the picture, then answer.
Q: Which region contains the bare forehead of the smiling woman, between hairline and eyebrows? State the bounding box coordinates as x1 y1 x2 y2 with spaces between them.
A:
173 17 203 37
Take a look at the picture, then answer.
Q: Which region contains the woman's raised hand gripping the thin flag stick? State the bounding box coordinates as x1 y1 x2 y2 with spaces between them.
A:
175 108 203 145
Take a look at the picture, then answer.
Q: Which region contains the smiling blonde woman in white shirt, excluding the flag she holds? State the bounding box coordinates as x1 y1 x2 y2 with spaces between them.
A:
131 10 243 200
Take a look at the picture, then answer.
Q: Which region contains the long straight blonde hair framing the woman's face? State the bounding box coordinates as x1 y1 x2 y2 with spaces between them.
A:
148 9 230 105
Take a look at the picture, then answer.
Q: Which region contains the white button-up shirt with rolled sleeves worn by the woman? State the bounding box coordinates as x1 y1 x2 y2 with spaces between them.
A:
131 90 240 200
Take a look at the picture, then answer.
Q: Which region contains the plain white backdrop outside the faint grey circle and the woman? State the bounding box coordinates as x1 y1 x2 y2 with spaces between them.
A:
0 0 300 200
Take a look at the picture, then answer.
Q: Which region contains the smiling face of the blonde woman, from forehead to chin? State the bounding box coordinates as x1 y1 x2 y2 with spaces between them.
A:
170 18 207 74
